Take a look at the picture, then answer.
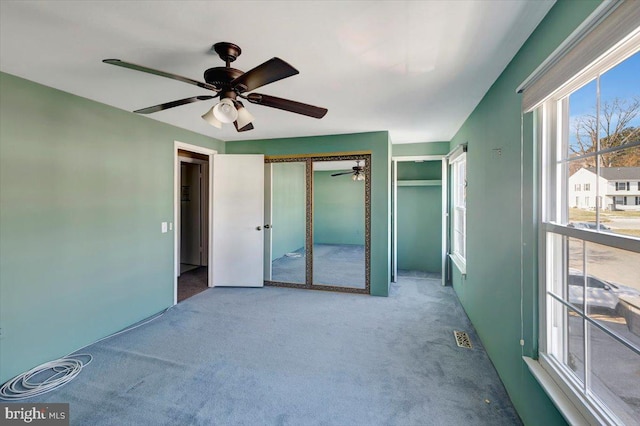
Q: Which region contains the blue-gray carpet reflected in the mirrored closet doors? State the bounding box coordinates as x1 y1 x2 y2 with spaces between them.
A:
271 244 366 288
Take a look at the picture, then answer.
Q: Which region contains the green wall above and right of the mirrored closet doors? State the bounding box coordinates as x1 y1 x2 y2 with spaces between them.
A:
225 132 391 296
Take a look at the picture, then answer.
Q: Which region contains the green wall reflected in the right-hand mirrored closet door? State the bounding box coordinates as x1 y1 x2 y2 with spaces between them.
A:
313 171 364 245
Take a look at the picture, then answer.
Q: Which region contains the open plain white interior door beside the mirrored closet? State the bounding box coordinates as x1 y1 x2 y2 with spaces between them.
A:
210 154 264 287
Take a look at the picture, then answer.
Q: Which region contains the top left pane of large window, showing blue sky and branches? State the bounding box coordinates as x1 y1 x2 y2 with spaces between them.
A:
563 80 598 161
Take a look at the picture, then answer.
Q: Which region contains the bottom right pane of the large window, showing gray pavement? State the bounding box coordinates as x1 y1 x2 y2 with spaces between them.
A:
589 324 640 425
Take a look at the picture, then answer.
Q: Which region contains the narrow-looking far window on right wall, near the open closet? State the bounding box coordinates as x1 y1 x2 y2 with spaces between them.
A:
450 152 467 272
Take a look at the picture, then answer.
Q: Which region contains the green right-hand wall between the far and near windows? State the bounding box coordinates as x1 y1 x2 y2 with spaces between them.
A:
451 0 600 425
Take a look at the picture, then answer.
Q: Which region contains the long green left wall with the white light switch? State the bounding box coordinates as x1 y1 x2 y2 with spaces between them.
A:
0 73 224 383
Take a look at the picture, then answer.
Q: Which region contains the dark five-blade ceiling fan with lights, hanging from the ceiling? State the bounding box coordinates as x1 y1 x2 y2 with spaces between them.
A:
102 42 327 132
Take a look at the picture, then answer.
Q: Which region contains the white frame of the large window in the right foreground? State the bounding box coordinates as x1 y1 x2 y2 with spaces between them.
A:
534 34 640 424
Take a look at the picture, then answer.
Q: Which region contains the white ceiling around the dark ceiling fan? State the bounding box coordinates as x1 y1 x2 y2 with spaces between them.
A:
0 0 554 143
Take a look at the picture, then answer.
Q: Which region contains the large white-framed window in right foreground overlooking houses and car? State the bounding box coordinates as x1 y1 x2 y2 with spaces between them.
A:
537 39 640 424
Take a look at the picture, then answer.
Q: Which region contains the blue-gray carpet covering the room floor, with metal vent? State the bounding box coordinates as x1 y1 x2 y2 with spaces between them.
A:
21 274 521 426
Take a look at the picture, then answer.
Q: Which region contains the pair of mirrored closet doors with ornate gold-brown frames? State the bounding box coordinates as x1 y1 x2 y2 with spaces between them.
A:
265 153 371 294
